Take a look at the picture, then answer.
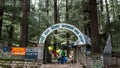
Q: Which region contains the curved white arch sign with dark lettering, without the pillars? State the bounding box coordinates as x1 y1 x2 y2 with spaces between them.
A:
39 23 85 45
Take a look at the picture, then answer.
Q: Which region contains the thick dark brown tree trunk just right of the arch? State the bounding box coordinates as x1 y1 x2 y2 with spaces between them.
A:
90 0 100 53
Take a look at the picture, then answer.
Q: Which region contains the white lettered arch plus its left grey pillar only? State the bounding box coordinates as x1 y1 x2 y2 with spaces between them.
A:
38 23 86 61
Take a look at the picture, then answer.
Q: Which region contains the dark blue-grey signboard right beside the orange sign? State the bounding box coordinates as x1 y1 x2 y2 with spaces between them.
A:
26 48 38 59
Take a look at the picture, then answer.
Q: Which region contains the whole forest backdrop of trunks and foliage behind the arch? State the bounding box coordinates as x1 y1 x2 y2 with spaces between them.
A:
0 0 120 53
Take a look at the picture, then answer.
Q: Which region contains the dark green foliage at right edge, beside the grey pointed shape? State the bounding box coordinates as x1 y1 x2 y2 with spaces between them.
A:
111 21 120 53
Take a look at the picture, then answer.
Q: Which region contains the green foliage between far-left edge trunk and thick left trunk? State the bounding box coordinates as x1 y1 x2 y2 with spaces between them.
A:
1 1 21 45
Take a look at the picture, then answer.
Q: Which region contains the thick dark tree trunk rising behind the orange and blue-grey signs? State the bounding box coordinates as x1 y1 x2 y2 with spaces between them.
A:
20 0 30 47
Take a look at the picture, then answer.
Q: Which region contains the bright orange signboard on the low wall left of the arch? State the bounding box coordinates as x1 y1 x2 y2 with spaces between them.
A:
12 47 26 56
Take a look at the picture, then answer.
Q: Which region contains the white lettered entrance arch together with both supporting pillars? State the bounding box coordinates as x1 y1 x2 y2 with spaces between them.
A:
38 23 86 66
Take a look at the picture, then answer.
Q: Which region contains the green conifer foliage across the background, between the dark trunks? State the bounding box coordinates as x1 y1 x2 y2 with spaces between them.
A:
0 0 120 52
